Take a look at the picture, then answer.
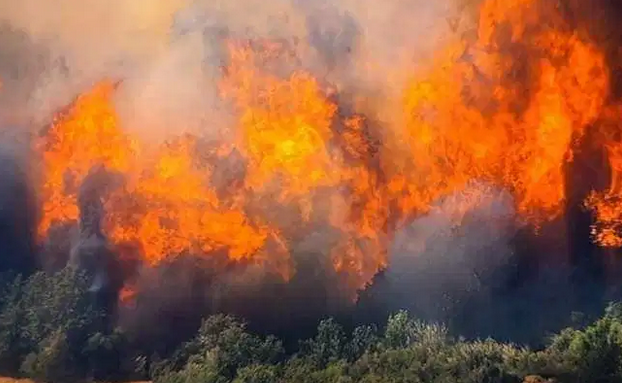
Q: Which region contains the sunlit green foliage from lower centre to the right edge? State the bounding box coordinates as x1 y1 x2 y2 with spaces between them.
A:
154 305 622 383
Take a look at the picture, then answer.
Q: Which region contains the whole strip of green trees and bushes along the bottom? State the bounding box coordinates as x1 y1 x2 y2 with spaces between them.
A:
0 270 622 383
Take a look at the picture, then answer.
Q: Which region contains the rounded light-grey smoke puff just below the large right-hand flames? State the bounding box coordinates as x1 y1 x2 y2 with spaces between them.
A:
386 184 517 321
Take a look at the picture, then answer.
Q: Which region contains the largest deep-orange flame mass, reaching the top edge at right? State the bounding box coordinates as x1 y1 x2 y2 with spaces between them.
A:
391 1 608 228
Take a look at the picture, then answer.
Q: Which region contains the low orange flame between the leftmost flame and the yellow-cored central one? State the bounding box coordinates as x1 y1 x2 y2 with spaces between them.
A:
107 140 286 264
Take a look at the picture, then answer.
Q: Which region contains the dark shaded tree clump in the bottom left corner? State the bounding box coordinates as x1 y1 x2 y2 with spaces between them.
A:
0 269 132 382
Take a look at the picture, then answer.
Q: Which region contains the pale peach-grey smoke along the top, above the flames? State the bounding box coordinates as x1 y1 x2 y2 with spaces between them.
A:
0 0 456 140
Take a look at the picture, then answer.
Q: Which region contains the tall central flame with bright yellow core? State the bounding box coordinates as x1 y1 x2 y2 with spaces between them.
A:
221 43 386 289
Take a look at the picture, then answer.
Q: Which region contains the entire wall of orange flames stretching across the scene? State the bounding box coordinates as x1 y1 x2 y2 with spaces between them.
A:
33 0 622 304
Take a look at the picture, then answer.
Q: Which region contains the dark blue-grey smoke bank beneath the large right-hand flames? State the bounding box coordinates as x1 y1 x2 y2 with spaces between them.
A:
355 183 604 347
